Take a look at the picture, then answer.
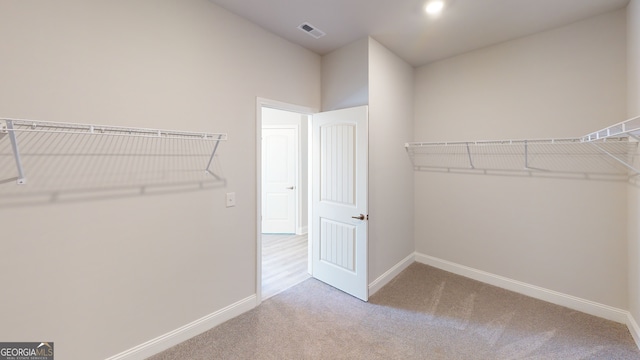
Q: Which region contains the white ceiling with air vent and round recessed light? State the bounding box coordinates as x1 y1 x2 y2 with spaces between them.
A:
210 0 629 66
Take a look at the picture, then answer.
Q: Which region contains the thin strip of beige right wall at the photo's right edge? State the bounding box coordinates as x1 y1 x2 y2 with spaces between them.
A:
627 0 640 323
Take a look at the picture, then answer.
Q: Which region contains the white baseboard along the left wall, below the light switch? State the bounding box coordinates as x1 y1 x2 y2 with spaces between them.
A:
106 295 256 360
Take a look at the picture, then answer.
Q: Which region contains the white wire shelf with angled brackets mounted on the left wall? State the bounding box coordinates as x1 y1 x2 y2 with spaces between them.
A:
0 118 227 184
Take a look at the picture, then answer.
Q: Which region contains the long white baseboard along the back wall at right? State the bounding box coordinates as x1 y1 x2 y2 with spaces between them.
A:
415 253 629 324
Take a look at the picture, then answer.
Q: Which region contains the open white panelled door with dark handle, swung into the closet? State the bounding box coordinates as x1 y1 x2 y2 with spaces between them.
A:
311 106 369 301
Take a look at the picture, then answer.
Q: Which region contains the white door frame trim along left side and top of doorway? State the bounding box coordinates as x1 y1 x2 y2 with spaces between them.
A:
255 97 319 306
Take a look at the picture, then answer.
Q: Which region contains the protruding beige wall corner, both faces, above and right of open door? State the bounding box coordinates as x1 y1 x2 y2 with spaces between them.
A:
322 38 414 290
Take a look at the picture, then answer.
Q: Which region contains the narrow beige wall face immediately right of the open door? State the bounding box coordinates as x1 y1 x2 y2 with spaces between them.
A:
369 38 414 282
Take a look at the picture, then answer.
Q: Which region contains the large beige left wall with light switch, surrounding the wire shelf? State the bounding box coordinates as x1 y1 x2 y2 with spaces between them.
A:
0 0 321 360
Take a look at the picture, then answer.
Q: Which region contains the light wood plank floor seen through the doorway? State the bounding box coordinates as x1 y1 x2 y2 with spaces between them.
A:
262 234 310 300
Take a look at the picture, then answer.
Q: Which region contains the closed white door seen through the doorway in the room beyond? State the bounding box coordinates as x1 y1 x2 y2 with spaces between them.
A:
262 128 298 234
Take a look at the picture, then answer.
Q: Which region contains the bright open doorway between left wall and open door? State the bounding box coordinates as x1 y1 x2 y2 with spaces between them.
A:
257 99 313 301
